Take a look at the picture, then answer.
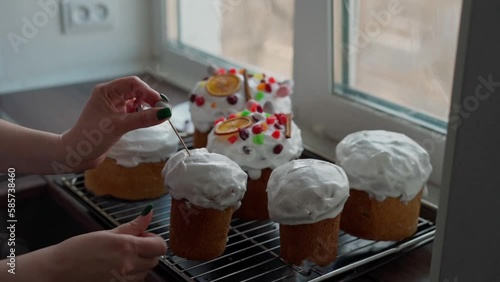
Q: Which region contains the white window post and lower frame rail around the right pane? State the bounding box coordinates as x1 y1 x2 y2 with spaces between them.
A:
292 0 446 189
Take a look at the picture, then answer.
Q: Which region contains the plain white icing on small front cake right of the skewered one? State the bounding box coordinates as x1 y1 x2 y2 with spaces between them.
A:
267 159 349 225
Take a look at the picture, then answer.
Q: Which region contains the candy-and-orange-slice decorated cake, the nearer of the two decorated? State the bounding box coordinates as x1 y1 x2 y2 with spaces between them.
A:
207 108 303 220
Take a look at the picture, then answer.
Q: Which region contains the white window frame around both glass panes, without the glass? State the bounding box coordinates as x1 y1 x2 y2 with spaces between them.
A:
152 0 446 195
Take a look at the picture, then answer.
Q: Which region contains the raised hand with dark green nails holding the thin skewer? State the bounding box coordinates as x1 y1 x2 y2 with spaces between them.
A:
56 76 172 174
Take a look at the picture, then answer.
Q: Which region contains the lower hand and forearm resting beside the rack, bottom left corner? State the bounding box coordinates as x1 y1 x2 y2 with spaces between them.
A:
0 206 167 282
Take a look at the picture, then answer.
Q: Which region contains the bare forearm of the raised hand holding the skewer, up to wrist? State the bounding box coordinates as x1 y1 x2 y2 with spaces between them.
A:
0 120 64 174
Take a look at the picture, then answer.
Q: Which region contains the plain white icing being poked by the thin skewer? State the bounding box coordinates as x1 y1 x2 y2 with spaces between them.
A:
162 148 247 210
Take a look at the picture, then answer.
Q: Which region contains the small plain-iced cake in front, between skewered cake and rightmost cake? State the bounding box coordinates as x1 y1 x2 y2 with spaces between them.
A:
267 159 349 266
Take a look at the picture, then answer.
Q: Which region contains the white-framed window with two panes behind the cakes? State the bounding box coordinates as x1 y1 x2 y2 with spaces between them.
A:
153 0 462 192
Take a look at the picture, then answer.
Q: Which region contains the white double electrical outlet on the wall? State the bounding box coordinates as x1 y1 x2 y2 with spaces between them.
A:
61 0 117 33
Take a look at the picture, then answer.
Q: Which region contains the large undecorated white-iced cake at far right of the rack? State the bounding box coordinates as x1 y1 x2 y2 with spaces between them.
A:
336 130 432 241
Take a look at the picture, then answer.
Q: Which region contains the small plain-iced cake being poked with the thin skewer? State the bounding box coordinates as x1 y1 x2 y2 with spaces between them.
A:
162 148 247 260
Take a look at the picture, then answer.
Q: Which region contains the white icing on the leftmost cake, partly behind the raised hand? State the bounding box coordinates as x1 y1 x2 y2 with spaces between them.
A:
107 122 179 167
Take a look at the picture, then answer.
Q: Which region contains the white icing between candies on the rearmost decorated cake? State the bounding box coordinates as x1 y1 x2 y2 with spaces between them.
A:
190 74 293 132
